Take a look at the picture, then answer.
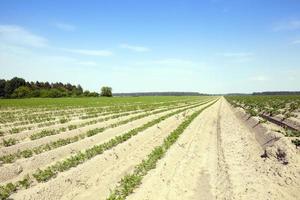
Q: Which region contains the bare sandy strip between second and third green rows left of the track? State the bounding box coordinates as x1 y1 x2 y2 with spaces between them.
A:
0 102 204 183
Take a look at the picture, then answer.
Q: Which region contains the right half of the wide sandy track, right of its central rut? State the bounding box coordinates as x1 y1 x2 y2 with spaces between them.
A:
219 100 300 199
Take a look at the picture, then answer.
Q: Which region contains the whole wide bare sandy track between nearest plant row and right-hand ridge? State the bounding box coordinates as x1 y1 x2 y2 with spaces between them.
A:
127 98 300 200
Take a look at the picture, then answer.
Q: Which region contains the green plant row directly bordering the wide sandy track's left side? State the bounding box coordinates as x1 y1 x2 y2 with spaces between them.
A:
107 99 215 200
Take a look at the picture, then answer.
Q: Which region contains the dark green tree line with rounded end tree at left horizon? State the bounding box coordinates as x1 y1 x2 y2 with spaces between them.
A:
0 77 112 98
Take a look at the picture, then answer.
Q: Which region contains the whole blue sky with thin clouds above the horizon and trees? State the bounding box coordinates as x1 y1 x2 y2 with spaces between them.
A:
0 0 300 93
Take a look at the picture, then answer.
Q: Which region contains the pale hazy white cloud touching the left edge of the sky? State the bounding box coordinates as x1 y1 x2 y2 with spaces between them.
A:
0 25 48 47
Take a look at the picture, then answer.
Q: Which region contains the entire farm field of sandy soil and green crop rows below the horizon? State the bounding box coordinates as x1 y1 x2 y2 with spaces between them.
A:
0 96 300 200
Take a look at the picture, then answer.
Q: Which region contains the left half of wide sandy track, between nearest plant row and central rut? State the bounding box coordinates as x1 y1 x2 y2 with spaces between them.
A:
128 96 221 200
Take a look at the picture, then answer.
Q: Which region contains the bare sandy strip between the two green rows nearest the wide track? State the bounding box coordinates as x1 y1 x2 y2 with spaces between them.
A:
12 101 211 199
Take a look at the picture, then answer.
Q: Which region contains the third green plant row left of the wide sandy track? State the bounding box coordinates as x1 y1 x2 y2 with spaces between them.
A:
0 102 210 163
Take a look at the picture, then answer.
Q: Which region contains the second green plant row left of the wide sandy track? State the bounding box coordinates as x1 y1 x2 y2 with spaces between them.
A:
0 99 217 200
